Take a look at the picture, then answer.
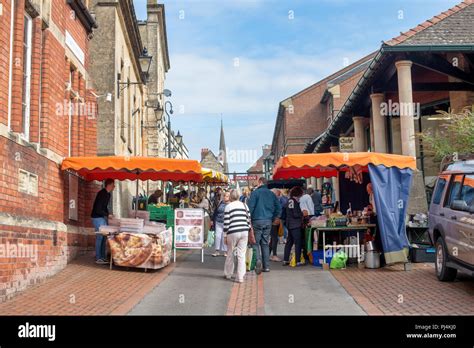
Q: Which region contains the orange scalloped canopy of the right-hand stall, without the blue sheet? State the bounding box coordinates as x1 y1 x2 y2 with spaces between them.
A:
273 152 416 180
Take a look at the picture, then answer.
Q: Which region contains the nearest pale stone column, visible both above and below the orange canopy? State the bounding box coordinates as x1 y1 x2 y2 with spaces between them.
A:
395 60 428 214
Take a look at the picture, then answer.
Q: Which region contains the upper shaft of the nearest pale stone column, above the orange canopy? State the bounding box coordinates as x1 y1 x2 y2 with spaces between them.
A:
395 60 416 156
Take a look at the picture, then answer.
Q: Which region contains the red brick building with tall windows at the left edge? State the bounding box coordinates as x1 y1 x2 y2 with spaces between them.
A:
0 0 97 301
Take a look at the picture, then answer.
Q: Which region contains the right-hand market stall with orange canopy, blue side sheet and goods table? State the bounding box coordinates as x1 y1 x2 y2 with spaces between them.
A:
273 152 416 264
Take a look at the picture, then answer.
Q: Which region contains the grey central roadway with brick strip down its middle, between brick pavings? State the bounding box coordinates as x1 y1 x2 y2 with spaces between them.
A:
129 246 366 315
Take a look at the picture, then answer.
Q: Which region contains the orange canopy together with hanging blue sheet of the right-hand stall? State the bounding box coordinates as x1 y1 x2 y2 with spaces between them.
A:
273 152 416 264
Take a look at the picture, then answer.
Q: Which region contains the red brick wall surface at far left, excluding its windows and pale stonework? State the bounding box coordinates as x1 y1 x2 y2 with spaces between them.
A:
0 0 99 302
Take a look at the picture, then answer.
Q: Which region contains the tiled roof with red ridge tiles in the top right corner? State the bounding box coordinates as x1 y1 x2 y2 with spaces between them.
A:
385 0 474 46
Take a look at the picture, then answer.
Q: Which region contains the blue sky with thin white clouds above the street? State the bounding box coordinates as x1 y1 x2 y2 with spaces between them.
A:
134 0 460 172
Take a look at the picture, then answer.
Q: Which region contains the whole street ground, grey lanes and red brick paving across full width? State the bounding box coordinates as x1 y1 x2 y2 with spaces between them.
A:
0 245 474 315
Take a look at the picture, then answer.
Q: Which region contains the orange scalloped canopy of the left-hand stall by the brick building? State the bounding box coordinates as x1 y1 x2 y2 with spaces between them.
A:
61 156 202 182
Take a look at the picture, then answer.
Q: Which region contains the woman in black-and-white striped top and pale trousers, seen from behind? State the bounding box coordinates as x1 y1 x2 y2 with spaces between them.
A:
224 190 250 283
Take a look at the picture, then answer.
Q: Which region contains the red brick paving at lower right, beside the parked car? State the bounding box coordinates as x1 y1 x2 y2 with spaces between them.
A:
331 263 474 315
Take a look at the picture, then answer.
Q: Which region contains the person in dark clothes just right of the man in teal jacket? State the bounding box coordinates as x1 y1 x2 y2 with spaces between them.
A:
283 186 304 266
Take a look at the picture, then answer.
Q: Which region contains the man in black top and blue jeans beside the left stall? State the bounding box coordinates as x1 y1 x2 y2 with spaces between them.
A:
91 179 115 264
